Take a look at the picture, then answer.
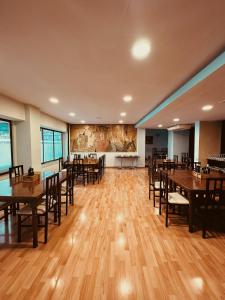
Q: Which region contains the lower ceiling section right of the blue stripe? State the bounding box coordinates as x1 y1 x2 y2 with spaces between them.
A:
141 66 225 128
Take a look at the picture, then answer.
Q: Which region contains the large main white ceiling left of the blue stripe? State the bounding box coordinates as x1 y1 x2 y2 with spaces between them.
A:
0 0 225 123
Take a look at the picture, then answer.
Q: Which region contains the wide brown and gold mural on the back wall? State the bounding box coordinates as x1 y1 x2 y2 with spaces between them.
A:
70 125 137 152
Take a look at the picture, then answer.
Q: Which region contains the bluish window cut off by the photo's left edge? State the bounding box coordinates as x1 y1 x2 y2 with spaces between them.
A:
0 119 12 173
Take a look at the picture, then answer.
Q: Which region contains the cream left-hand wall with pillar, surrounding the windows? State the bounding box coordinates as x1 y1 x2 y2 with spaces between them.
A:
0 95 68 171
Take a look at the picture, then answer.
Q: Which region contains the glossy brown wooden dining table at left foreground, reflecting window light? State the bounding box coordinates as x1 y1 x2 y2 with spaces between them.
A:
0 170 67 248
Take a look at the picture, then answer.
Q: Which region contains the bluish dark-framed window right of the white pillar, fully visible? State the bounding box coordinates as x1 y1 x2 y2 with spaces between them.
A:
41 128 63 163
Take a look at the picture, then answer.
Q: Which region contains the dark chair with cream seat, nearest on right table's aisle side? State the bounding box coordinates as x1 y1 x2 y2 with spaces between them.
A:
162 171 189 227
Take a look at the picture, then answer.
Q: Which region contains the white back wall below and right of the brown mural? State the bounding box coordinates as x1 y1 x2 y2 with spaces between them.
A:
71 128 145 167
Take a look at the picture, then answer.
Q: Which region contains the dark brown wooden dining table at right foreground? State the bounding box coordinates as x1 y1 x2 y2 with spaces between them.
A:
162 170 225 232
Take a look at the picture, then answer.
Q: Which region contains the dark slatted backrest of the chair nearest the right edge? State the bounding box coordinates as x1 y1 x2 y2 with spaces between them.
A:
204 178 225 206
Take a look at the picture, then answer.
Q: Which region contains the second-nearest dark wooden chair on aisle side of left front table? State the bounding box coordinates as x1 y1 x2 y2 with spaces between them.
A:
61 166 74 215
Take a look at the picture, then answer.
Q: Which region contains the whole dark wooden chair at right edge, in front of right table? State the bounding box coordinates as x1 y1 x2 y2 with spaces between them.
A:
200 178 225 238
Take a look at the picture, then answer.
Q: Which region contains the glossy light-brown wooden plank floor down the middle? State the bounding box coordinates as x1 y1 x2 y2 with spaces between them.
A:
0 169 225 300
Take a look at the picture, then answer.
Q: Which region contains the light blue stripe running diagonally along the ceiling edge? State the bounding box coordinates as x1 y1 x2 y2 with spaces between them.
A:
136 51 225 127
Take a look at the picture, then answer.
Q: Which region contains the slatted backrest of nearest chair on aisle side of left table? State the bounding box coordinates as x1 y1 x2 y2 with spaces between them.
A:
46 173 60 210
